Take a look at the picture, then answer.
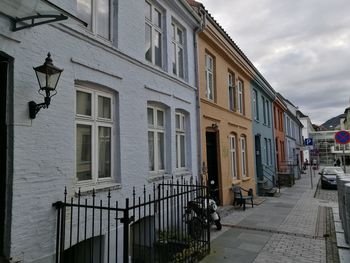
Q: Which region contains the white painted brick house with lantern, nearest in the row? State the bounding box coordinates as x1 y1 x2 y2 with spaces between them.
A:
0 0 200 262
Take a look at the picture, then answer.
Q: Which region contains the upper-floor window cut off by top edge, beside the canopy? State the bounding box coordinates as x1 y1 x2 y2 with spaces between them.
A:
77 0 111 40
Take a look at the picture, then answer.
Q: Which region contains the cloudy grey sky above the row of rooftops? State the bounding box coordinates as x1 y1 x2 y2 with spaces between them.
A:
197 0 350 124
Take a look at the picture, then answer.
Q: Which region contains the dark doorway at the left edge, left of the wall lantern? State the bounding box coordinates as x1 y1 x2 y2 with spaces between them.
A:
0 51 13 259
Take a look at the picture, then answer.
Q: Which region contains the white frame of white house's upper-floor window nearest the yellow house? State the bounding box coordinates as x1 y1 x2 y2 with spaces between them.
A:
171 22 186 79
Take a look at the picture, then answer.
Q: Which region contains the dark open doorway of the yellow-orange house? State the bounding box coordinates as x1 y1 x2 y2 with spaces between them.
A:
206 131 220 204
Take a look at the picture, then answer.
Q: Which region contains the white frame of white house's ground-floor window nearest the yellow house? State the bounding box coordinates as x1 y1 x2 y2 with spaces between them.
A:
175 111 187 170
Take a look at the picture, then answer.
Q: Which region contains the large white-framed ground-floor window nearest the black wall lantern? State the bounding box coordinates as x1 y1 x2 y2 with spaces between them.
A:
75 88 114 182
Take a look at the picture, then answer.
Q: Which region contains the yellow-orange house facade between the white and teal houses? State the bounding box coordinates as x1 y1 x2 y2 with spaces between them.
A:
197 9 256 205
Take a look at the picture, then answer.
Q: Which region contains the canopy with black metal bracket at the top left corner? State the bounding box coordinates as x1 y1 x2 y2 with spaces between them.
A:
0 0 87 31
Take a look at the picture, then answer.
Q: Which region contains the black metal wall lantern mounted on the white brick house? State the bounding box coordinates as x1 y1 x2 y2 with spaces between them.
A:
28 53 63 119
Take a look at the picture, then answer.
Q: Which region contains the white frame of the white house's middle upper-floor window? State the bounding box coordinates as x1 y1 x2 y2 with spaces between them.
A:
145 1 164 68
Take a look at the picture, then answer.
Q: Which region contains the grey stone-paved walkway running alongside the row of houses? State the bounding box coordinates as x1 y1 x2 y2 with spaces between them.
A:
202 169 338 263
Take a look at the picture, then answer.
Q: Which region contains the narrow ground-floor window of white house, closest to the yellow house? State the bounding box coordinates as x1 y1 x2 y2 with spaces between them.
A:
175 112 186 169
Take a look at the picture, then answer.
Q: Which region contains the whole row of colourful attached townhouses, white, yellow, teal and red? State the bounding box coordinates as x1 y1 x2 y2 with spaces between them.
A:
0 0 303 262
